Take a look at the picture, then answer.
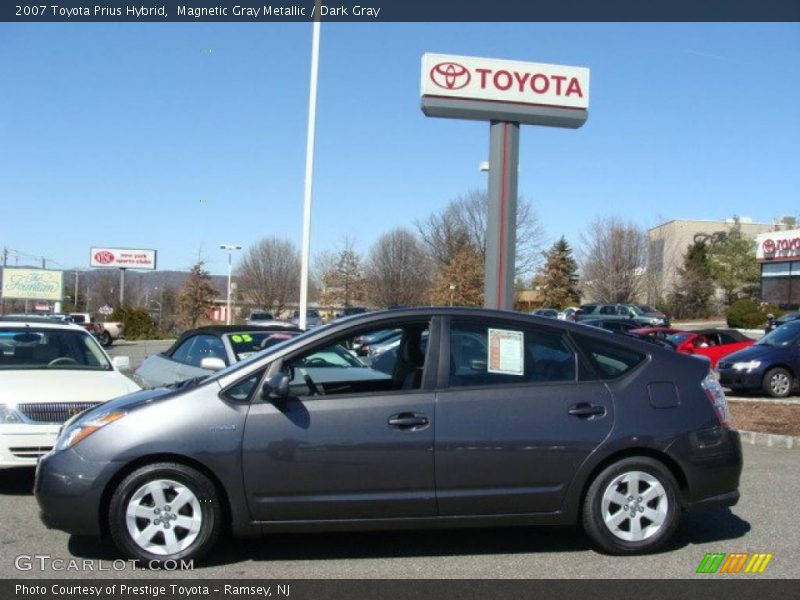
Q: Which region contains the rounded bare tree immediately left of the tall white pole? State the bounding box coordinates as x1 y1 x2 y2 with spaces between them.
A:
236 237 300 312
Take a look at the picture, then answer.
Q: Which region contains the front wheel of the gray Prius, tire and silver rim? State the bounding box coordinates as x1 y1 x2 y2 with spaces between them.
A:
108 463 222 566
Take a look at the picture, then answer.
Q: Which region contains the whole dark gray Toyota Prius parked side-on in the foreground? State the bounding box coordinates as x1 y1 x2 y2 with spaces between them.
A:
35 308 742 561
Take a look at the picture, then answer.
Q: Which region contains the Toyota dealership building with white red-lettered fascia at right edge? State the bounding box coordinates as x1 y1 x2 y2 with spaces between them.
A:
756 229 800 310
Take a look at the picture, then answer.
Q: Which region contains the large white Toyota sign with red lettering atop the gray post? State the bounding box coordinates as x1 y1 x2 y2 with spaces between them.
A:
422 54 589 128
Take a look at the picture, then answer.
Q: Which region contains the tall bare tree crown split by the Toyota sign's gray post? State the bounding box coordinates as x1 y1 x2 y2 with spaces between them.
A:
416 190 544 278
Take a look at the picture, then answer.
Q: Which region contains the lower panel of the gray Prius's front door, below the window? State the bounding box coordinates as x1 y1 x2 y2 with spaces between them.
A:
243 391 436 521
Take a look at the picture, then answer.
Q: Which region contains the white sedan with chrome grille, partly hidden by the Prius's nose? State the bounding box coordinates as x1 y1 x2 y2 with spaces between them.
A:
0 319 140 468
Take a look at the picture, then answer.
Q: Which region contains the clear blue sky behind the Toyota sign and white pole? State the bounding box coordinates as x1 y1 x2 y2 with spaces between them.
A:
0 23 800 273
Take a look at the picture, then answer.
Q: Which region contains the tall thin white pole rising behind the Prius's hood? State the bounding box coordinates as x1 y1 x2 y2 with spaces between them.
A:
298 7 320 329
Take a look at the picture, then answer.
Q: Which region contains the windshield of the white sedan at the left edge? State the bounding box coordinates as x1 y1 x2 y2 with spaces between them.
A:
0 327 111 371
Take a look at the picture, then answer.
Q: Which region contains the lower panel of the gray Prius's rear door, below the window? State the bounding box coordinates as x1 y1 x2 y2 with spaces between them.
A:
436 382 614 515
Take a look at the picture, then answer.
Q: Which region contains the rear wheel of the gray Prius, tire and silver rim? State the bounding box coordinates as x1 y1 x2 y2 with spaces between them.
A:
582 456 681 555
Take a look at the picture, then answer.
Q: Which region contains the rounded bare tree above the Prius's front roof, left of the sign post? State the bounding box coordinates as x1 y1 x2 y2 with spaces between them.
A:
367 228 432 306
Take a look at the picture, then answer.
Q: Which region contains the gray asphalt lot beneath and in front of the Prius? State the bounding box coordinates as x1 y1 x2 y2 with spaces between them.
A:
0 446 800 579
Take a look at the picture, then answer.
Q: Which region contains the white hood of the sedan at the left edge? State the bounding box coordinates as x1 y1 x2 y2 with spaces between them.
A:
0 369 139 403
